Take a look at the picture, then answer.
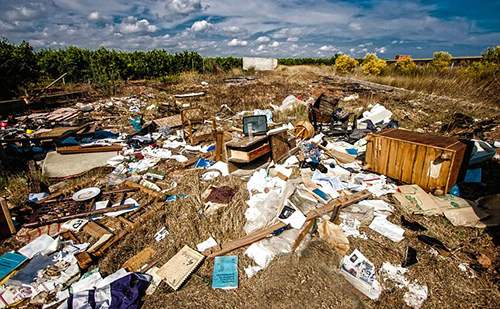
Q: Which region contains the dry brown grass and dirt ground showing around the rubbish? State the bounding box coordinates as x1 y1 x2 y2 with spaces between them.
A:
0 66 500 308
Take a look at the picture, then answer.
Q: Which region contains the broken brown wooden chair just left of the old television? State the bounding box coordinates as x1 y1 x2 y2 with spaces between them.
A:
181 107 216 144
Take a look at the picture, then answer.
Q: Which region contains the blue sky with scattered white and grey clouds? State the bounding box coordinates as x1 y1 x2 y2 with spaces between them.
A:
0 0 500 58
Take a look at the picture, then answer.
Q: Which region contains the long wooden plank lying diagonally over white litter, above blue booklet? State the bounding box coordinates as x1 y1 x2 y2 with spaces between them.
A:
203 190 371 258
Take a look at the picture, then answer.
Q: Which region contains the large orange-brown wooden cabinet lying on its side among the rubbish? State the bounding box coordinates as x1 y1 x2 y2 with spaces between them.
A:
365 129 468 195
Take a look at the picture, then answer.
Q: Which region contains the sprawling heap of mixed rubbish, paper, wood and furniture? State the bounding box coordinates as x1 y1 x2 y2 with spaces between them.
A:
0 88 500 308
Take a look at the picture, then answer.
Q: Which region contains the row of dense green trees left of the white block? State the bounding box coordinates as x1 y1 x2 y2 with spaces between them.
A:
0 39 246 99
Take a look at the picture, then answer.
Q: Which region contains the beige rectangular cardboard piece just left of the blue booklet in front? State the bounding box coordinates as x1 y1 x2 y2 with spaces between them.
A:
156 246 205 291
